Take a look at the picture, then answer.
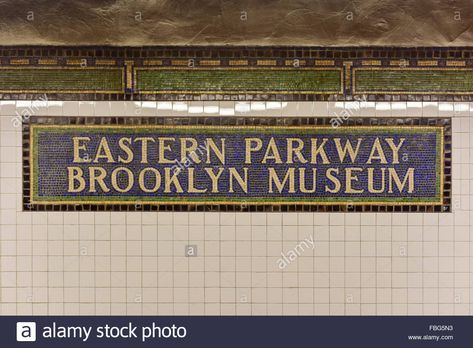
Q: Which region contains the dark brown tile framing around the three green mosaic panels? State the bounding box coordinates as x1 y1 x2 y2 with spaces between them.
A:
0 46 473 101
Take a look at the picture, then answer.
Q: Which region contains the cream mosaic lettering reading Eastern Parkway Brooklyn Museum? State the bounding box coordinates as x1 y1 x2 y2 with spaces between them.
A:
66 136 417 195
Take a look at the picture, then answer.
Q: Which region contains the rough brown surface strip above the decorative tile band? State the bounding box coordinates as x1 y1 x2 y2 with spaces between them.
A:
0 0 473 46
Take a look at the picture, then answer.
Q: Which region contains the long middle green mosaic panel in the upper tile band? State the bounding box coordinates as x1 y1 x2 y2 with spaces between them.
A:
136 68 342 94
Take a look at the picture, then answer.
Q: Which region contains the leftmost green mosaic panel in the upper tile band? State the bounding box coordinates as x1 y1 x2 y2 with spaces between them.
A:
0 68 123 93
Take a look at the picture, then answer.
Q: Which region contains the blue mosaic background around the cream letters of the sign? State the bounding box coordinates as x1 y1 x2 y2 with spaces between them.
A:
32 127 437 201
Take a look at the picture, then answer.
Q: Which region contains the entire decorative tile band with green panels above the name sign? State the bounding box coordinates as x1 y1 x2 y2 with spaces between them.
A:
0 46 473 101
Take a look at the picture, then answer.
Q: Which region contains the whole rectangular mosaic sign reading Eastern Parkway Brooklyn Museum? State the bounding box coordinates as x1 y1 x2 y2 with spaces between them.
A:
24 117 450 211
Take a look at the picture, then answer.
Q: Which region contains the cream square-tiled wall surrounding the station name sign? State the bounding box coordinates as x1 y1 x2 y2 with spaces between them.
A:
0 101 473 315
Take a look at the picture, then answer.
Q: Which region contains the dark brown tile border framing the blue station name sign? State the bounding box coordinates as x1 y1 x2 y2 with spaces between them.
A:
22 116 452 212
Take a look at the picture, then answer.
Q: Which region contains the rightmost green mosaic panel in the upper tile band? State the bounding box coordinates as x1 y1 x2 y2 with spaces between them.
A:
354 68 473 94
